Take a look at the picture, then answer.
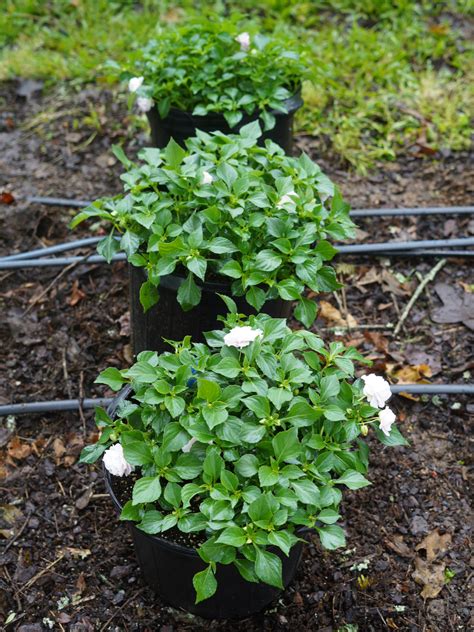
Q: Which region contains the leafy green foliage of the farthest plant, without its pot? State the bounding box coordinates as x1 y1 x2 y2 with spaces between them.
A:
115 16 307 129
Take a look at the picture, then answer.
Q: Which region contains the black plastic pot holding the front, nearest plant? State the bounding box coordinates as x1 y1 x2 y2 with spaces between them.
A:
104 468 303 619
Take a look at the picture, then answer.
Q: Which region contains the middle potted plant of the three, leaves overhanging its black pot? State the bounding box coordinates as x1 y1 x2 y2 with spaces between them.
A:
72 122 354 353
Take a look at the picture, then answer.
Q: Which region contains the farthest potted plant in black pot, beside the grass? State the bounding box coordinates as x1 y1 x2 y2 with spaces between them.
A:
112 18 307 153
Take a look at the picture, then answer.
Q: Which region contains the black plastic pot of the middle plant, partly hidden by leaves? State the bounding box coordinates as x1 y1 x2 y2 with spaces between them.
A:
129 266 292 354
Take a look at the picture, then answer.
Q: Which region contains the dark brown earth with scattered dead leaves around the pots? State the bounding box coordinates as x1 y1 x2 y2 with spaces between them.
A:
0 83 474 632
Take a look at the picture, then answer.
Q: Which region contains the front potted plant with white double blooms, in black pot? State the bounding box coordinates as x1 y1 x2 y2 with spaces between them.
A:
81 308 406 618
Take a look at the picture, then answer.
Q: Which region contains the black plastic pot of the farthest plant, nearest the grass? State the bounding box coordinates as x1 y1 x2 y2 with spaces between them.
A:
147 93 303 155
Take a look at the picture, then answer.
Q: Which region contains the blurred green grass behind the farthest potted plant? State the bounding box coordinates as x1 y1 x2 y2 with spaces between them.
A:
0 0 474 172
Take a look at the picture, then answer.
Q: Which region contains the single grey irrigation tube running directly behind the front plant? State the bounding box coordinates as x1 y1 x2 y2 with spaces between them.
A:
0 384 474 417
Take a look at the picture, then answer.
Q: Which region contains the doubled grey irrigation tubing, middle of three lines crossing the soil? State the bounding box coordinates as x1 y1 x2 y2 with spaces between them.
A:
0 237 474 270
